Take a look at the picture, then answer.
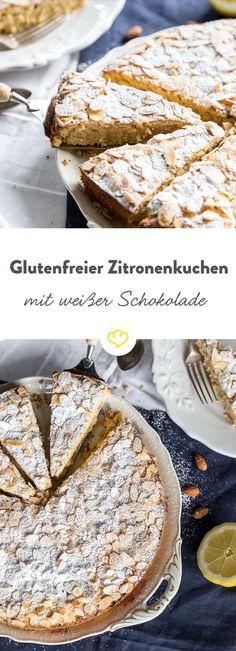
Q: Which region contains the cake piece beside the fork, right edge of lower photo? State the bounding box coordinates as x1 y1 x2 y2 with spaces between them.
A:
202 339 236 416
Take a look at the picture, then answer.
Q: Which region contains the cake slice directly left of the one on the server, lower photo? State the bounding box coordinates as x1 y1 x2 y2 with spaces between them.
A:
0 387 51 491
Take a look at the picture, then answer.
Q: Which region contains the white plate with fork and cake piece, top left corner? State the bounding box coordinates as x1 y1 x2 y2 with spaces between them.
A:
0 0 125 72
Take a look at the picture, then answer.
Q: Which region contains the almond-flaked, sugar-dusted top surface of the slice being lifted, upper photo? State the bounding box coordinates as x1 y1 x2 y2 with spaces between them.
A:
48 72 199 141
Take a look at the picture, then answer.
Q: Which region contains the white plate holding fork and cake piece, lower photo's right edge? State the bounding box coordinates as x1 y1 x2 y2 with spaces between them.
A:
152 339 236 457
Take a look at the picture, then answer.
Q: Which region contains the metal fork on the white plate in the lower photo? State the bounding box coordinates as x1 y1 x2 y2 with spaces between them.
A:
185 339 217 404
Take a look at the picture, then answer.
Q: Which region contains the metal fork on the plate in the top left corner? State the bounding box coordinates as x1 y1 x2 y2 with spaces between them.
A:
0 15 66 50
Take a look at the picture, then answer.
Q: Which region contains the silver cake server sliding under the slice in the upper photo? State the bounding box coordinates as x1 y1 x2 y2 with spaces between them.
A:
0 82 104 153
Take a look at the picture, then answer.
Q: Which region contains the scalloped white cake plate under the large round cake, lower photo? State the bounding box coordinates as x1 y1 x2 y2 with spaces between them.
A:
0 377 182 645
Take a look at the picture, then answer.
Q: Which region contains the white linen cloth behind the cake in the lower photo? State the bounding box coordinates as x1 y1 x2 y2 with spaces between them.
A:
0 339 164 409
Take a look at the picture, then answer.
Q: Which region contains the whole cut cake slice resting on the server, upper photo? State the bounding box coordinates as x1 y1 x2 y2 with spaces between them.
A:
46 72 199 147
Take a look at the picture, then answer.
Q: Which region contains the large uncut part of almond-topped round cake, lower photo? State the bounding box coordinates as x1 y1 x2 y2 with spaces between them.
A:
0 419 166 628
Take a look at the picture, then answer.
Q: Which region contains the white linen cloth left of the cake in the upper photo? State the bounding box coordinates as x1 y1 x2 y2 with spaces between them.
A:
0 54 78 228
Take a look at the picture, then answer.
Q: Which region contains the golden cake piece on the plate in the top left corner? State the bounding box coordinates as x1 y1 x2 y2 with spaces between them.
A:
0 0 84 34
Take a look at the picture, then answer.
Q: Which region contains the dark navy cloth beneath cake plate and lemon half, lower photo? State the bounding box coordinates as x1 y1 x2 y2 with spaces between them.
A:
0 409 236 651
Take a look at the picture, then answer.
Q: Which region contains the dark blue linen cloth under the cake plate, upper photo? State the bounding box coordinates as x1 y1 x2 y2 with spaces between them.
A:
66 0 218 228
